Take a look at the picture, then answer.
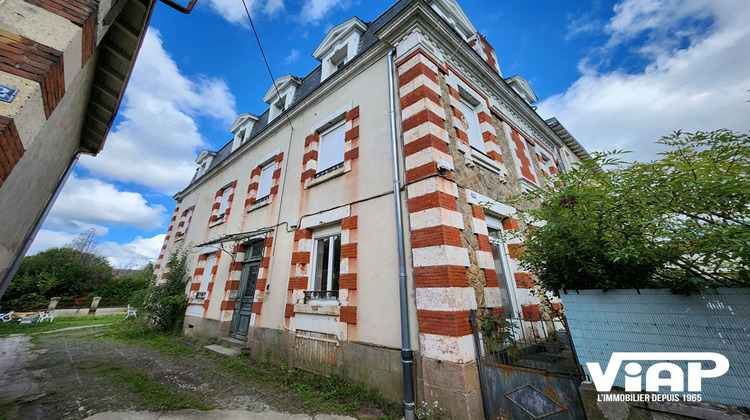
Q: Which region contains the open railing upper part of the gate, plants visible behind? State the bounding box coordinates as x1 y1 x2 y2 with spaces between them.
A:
474 308 581 376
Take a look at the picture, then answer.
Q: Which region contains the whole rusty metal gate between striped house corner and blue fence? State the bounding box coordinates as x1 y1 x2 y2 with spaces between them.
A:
471 308 586 420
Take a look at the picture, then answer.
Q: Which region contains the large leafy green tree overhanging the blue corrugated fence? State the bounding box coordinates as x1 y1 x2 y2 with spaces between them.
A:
518 130 750 294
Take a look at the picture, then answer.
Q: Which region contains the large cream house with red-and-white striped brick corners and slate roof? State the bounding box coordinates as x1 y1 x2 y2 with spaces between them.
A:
155 0 588 418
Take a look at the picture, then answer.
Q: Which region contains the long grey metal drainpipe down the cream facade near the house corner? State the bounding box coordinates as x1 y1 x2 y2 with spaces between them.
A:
388 48 414 420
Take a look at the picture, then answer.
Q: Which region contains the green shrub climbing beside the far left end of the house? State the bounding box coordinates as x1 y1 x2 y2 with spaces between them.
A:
139 252 190 332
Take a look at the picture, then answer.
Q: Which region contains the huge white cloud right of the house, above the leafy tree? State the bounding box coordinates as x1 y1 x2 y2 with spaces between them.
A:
538 0 750 160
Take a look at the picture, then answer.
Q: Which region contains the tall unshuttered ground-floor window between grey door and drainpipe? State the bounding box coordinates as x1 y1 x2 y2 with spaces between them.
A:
306 226 341 300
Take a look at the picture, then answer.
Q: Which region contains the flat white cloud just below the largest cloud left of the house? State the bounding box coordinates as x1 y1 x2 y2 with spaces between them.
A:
50 176 167 233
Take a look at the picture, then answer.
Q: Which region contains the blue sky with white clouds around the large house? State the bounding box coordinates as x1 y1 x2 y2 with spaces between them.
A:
30 0 750 267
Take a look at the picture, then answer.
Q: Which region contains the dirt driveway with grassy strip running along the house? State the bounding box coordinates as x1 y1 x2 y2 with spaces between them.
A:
0 329 358 420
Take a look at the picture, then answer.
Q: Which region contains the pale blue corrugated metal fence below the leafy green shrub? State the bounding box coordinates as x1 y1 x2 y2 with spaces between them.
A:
561 289 750 407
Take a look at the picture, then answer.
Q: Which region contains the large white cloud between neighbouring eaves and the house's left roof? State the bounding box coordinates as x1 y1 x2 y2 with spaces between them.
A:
81 28 236 195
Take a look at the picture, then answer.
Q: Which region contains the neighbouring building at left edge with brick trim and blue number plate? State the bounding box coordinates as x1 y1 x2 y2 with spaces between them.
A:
0 0 156 296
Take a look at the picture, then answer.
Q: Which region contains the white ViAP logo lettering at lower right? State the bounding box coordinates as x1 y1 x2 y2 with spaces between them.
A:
586 352 729 392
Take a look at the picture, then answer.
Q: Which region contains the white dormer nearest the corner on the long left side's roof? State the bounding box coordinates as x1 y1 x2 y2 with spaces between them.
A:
313 17 367 82
